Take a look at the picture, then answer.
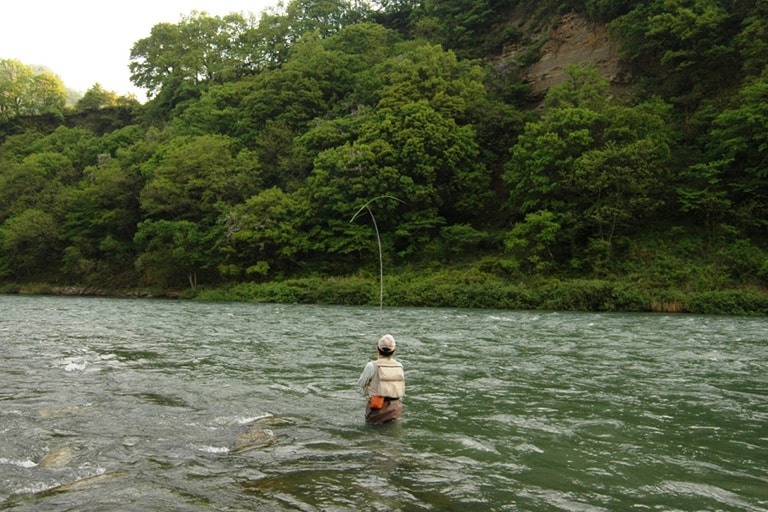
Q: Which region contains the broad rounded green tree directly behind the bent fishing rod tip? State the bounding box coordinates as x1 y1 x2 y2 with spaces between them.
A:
308 101 489 255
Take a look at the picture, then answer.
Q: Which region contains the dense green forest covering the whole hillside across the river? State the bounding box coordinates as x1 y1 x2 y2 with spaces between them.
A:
0 0 768 314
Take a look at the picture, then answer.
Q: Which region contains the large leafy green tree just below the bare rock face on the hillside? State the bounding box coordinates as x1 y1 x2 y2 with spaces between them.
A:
504 64 671 268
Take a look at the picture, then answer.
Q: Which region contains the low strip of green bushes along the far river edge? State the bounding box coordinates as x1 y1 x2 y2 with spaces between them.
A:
7 270 768 315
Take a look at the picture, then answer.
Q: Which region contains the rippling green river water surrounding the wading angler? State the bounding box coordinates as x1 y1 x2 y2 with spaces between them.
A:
0 296 768 511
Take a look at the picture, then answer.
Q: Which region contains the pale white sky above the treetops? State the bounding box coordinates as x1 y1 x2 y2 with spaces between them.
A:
0 0 278 102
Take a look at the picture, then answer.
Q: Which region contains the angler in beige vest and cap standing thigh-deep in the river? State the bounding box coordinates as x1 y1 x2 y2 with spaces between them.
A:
357 334 405 423
